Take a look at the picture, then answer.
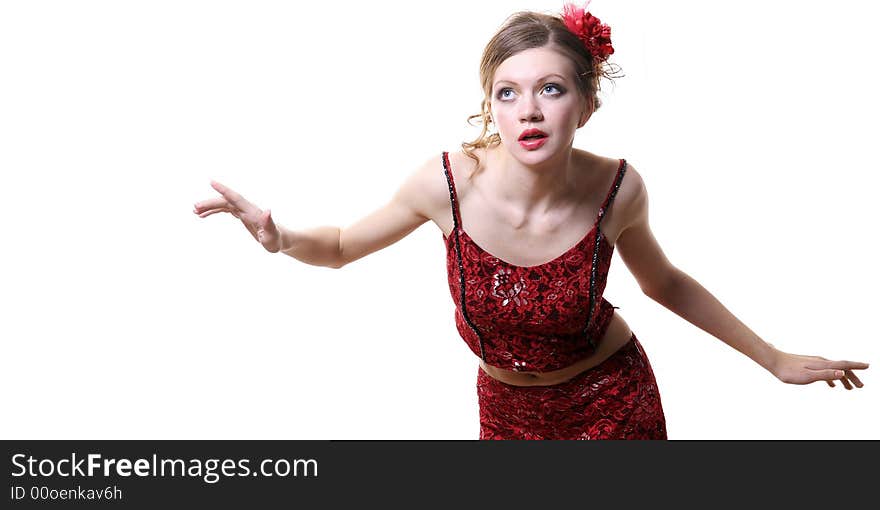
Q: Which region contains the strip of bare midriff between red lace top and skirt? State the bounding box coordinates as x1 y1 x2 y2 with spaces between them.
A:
480 312 632 386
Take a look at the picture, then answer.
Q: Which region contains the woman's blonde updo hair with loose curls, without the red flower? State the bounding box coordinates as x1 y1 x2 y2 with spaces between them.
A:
461 11 618 175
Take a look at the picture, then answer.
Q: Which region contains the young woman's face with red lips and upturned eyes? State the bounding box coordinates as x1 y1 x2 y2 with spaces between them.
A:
490 48 592 163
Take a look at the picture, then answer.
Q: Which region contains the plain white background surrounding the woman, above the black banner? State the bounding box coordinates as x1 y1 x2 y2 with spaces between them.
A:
0 0 880 439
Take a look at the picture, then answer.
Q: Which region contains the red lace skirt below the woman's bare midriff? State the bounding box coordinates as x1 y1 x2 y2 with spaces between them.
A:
477 333 667 439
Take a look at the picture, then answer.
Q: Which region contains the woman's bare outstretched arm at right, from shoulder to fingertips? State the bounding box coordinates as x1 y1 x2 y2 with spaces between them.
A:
616 168 868 389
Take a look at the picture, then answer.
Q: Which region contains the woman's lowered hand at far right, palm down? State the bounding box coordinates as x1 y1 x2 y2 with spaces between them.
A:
771 351 868 390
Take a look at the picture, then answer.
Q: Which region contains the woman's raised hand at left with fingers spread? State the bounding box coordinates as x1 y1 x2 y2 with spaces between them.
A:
193 181 281 253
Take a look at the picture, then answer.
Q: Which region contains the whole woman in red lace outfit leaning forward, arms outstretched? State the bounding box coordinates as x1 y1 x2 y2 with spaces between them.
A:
194 0 868 439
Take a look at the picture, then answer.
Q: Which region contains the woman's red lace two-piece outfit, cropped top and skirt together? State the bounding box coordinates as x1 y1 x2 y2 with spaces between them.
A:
442 152 666 439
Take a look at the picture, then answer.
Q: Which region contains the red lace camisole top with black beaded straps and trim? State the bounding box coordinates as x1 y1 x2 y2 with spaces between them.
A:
442 152 626 372
